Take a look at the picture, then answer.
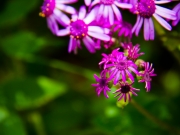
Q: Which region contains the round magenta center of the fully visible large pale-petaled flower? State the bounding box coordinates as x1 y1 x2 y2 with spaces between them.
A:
70 20 88 39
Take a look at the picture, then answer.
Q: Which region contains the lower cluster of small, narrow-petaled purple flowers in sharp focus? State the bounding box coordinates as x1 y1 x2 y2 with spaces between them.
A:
92 43 156 102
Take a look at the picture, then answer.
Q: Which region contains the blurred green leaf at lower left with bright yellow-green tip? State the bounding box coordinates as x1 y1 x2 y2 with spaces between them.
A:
1 77 67 110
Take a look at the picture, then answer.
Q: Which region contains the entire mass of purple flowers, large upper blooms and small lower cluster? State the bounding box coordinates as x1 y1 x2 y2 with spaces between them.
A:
39 0 180 101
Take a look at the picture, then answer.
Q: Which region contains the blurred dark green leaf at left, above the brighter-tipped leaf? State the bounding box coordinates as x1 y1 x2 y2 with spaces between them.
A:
2 31 46 58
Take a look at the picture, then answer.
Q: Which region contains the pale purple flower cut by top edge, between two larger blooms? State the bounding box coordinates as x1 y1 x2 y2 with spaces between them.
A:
90 0 132 25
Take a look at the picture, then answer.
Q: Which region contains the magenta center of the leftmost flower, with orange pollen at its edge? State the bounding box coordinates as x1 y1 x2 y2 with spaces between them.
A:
39 0 55 17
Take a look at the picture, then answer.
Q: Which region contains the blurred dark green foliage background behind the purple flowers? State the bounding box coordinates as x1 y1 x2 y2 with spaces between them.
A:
0 0 180 135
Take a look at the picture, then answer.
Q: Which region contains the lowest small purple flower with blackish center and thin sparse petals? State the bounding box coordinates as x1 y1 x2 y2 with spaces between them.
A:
114 82 140 102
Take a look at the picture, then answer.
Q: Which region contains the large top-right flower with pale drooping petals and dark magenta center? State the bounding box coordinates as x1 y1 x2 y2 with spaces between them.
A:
132 0 176 40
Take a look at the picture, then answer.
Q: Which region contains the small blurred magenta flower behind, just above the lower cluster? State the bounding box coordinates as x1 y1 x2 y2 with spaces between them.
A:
113 21 132 38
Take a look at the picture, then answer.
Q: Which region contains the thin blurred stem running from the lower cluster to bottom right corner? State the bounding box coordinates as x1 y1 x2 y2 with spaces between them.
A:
130 99 180 135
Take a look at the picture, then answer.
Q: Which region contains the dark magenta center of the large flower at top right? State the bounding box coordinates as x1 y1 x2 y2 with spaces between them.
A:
137 0 156 18
